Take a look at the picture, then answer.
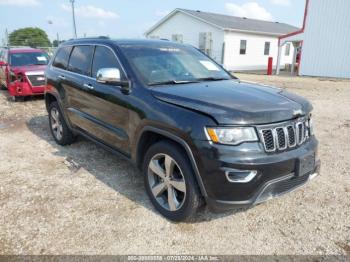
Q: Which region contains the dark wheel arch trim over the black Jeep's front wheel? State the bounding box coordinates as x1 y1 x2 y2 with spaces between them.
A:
135 126 207 198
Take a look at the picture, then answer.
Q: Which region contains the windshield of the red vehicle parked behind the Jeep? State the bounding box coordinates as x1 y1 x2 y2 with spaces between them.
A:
10 52 49 66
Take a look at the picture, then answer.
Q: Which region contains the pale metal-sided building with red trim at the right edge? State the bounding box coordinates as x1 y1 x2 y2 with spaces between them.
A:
277 0 350 78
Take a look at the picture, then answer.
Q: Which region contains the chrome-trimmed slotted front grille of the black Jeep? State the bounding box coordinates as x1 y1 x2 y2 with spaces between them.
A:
258 118 309 152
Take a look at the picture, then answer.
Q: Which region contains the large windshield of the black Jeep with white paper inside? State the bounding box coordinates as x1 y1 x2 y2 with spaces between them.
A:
120 44 232 85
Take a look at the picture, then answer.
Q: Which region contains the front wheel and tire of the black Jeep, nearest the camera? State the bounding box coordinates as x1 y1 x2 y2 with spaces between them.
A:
143 141 200 221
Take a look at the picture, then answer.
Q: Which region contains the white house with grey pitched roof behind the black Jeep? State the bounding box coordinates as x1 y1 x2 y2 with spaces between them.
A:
145 9 298 71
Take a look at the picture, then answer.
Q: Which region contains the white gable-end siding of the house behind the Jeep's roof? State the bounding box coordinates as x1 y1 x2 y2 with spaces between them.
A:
146 12 224 63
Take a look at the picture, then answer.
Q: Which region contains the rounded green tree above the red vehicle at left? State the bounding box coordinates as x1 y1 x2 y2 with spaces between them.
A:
9 27 51 47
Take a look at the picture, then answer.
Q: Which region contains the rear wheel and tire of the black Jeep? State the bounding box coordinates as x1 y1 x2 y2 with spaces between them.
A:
49 102 76 146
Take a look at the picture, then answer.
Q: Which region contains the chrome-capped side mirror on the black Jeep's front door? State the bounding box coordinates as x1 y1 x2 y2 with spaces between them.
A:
96 68 130 93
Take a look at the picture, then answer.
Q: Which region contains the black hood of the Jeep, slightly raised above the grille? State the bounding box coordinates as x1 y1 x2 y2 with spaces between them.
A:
152 80 312 125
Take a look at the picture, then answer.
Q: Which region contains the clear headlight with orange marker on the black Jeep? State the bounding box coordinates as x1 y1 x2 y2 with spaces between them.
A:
207 127 258 145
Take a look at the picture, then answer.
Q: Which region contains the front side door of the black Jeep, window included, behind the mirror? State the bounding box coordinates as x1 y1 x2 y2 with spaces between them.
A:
84 45 130 155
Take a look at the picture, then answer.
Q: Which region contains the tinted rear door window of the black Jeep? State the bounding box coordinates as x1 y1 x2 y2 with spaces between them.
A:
68 46 93 76
